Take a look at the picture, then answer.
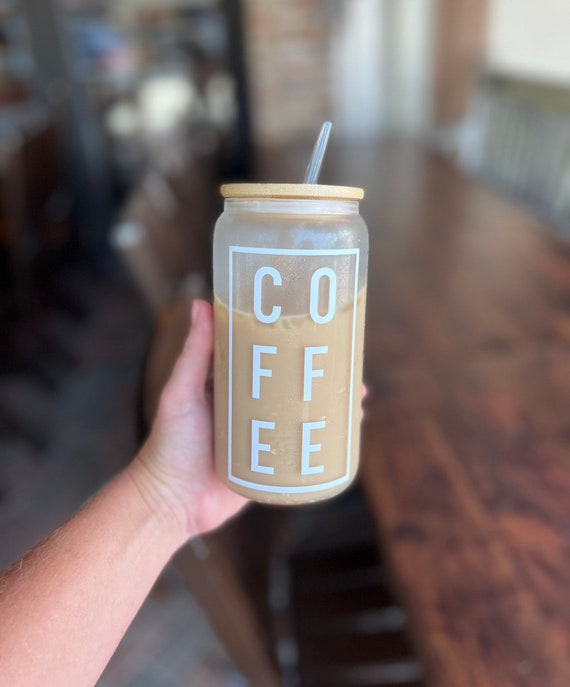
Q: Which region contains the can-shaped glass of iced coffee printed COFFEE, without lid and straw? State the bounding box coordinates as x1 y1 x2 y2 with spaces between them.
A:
214 185 368 504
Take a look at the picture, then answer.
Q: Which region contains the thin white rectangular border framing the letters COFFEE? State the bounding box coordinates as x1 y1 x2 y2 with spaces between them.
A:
228 246 360 494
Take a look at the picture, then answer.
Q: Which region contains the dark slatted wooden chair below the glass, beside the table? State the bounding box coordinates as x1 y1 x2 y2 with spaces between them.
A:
270 485 422 687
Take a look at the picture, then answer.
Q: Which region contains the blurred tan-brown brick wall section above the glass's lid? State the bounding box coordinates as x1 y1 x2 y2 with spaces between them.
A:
243 0 331 143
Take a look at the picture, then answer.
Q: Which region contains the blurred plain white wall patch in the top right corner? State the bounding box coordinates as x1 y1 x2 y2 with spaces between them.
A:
486 0 570 84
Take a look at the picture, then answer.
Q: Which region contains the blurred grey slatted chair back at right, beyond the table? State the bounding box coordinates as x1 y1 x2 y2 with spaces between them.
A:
459 76 570 235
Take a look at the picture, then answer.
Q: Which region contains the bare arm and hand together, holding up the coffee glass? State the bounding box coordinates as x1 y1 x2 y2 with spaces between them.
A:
0 301 245 687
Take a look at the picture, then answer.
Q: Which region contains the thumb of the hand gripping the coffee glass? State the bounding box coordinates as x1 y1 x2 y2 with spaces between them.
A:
160 299 214 416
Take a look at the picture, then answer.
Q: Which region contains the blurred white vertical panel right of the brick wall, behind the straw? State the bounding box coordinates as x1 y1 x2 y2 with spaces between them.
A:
331 0 434 138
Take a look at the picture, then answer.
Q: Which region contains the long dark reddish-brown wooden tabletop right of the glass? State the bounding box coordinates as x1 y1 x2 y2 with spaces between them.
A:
260 141 570 687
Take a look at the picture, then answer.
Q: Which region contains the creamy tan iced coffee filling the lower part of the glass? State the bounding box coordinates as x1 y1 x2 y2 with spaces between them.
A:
214 284 366 504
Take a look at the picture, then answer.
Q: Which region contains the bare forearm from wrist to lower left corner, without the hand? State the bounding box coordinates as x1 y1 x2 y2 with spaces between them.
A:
0 462 187 687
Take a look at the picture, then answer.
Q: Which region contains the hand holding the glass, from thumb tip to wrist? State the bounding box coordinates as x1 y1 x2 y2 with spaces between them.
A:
129 300 247 539
